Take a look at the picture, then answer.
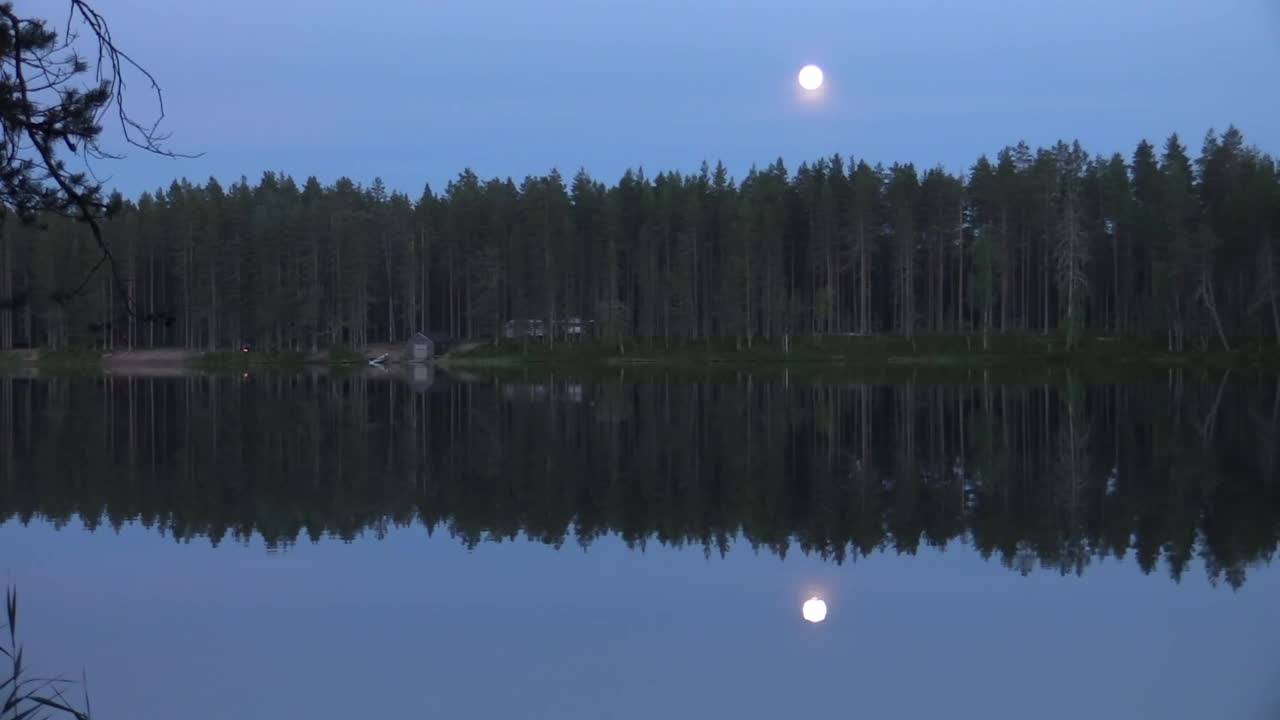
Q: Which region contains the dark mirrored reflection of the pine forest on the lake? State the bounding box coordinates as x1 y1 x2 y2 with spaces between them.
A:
0 370 1280 587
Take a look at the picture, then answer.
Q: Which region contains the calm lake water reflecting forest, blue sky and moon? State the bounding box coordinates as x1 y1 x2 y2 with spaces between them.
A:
0 370 1280 720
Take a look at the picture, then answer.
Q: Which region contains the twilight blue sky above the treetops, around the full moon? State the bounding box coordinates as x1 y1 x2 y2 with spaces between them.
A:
85 0 1280 195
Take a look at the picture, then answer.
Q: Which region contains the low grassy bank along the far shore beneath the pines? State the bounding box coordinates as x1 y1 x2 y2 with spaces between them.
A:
0 334 1280 374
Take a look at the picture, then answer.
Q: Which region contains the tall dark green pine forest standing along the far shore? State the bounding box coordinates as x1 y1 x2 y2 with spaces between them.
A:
0 127 1280 351
